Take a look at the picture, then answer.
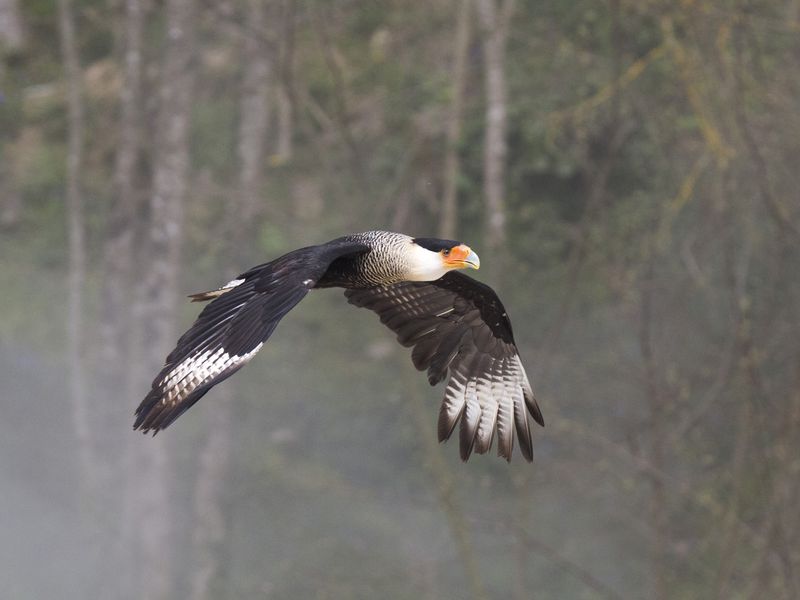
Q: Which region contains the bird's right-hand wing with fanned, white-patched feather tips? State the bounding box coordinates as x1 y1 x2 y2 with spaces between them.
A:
345 272 544 461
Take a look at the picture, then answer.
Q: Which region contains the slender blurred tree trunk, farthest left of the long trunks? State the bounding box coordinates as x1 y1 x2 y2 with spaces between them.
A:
58 0 97 491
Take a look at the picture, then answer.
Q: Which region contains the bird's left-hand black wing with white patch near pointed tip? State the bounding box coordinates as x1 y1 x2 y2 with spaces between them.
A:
133 240 367 433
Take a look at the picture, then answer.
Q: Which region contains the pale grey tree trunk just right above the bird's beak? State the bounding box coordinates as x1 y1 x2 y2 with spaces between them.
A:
477 0 514 254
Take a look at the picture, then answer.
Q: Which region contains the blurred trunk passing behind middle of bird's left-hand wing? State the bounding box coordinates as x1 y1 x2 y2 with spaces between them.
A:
191 0 273 600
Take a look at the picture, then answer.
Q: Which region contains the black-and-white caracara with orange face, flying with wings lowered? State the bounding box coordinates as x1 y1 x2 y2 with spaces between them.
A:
133 231 544 462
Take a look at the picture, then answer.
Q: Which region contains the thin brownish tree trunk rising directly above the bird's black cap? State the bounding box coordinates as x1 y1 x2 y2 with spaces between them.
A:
439 0 472 240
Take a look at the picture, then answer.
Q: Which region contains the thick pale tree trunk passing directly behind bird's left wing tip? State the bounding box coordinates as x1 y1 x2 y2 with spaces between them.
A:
134 0 195 599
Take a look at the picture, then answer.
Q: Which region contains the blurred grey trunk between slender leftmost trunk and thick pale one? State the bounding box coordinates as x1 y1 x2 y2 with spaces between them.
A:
104 0 145 597
